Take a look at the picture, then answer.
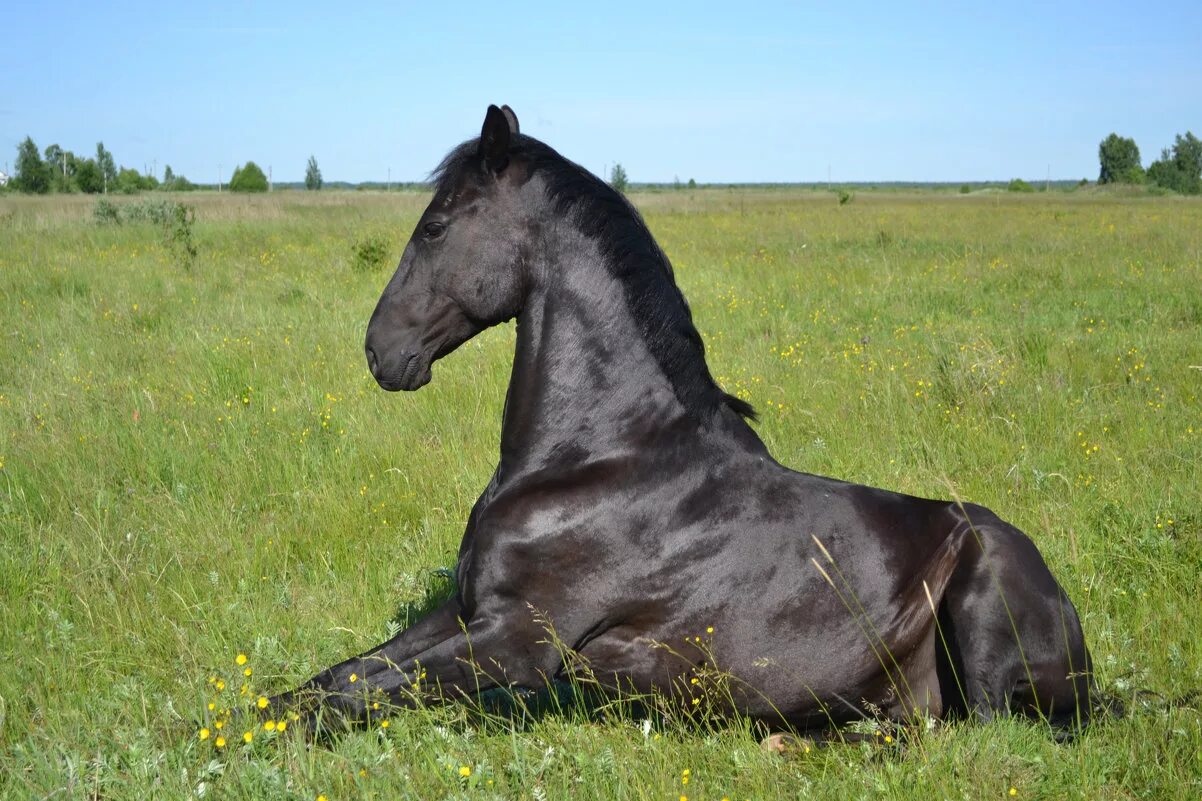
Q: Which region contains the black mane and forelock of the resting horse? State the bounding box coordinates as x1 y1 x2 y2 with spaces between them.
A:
430 135 756 420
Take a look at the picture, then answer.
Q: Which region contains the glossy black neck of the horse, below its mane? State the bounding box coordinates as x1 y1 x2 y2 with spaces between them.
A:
501 234 762 475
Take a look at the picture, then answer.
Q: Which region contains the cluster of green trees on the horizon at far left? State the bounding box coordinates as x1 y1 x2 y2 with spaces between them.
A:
11 136 195 195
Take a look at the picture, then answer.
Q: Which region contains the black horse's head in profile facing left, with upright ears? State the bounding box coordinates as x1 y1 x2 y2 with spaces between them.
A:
364 106 528 391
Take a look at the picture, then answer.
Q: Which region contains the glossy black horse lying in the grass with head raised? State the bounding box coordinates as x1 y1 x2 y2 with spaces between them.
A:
275 106 1093 730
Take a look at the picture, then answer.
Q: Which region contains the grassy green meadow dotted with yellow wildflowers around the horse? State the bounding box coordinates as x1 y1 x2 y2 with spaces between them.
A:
0 189 1202 801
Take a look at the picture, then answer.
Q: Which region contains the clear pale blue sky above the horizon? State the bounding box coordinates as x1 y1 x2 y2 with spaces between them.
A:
0 0 1202 182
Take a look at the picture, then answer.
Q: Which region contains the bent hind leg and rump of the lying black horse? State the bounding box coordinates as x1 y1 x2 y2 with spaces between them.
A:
935 505 1091 728
